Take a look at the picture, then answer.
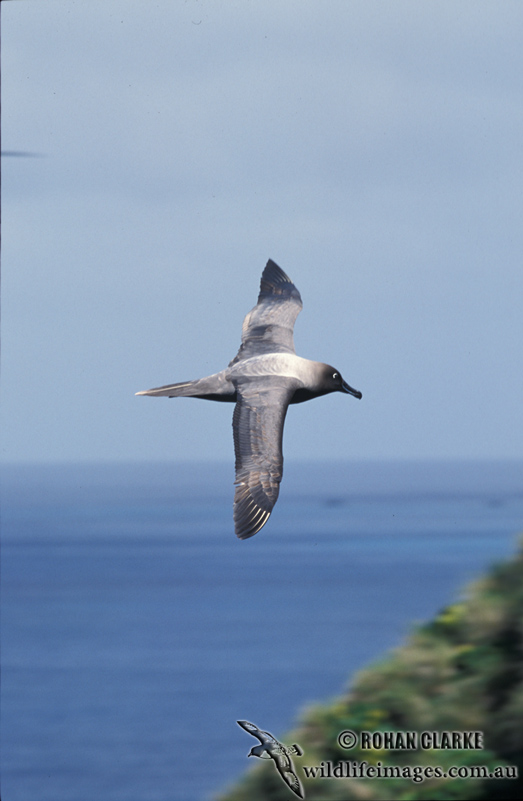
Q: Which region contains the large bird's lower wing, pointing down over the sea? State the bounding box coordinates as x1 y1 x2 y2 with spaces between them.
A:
232 376 298 540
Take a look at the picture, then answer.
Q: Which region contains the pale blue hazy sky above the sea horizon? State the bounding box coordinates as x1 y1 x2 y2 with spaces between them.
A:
0 0 523 462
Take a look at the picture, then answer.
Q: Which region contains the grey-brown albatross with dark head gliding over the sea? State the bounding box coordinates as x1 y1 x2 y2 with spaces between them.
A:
136 259 361 539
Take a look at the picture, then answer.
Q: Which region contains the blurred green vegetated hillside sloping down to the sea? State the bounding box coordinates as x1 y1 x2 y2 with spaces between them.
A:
219 536 523 801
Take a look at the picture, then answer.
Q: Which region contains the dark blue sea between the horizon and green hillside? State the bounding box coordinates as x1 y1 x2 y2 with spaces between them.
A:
1 461 523 801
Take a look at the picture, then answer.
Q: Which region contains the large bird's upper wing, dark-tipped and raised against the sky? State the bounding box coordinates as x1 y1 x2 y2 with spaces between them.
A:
229 259 302 366
